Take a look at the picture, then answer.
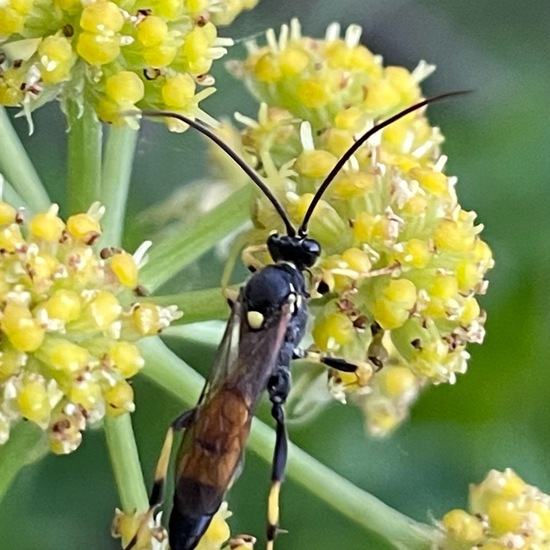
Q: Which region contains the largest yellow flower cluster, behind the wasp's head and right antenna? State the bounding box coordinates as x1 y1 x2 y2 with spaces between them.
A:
224 21 493 435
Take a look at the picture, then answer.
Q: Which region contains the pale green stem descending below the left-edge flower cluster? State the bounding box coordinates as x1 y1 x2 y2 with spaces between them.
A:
104 414 147 514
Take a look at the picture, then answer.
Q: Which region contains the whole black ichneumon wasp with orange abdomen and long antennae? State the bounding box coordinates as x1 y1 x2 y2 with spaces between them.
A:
125 92 465 550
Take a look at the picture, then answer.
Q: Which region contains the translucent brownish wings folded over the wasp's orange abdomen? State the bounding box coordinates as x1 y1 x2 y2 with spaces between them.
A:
174 293 292 518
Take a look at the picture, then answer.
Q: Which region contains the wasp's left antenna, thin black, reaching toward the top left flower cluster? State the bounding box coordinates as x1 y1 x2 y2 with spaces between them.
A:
141 111 296 237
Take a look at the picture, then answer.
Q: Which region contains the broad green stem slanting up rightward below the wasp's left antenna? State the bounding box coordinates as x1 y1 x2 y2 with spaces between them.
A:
140 186 250 291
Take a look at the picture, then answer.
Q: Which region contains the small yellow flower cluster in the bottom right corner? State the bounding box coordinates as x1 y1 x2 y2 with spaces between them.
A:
439 469 550 550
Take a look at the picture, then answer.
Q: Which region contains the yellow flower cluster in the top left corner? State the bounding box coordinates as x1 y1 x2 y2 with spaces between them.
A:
0 0 256 124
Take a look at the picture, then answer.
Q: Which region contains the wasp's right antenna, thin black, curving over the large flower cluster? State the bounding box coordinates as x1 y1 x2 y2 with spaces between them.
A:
298 90 471 236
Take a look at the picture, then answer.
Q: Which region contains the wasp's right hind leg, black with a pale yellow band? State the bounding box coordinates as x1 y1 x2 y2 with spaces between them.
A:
266 367 290 550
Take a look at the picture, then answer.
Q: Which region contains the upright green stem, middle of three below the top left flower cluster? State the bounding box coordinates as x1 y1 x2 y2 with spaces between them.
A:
67 102 103 214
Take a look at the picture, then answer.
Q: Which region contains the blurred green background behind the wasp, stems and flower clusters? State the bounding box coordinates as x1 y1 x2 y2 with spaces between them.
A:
0 0 550 550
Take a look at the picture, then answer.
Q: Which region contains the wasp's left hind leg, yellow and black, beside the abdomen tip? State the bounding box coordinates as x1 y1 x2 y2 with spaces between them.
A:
124 409 196 550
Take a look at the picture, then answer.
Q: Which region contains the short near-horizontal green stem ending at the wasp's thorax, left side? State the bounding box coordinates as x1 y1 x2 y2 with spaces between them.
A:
147 288 229 326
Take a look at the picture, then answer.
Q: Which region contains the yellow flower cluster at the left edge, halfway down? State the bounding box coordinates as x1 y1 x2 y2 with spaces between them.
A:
0 201 180 453
